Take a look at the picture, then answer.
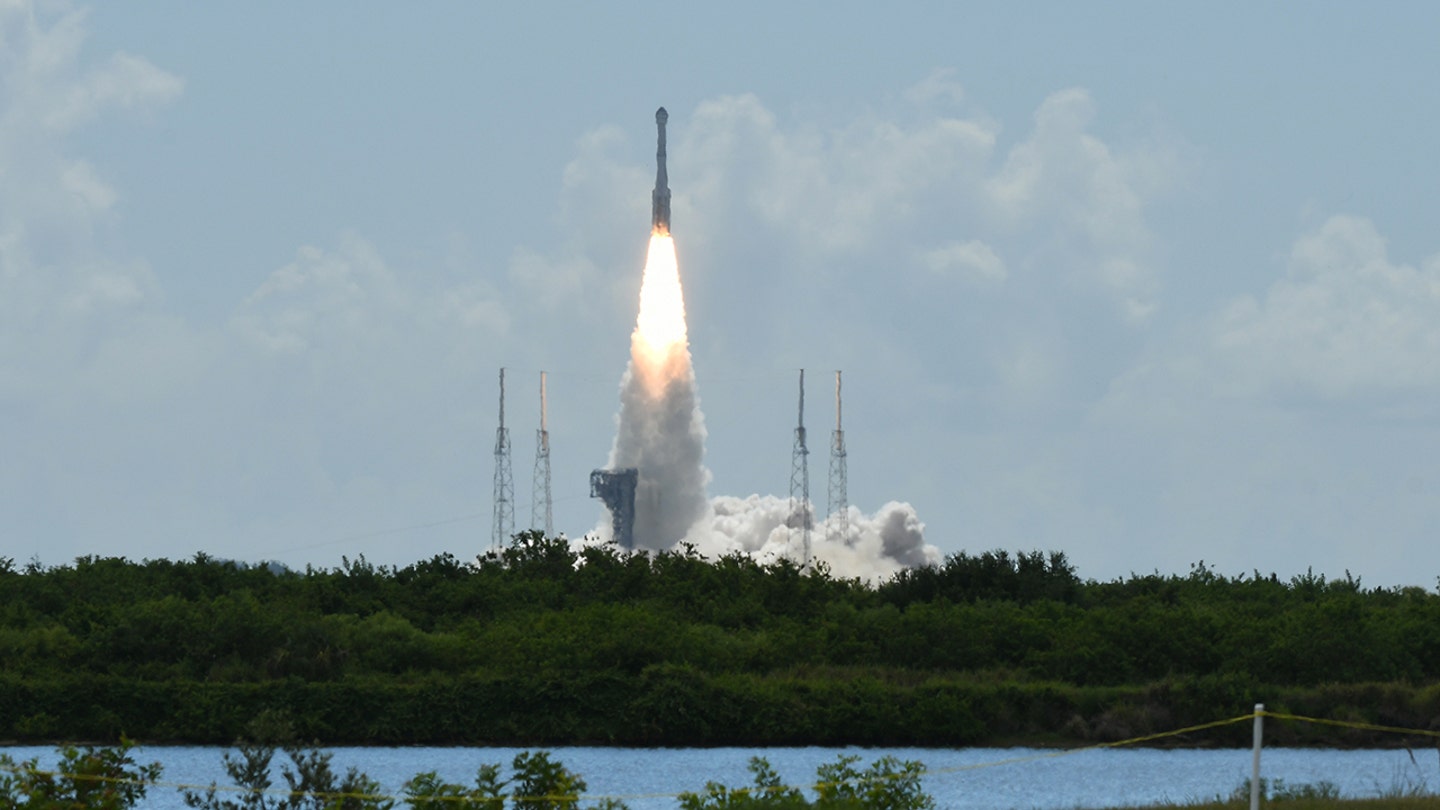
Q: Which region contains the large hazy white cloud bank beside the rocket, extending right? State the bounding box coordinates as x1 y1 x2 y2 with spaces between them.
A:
596 83 1182 332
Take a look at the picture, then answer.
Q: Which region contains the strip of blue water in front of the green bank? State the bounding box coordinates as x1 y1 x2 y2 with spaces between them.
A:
0 747 1440 810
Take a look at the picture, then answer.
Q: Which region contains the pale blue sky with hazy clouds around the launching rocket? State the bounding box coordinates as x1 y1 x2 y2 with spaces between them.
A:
0 0 1440 579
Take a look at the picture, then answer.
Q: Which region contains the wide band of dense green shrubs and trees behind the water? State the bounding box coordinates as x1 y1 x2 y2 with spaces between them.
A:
0 533 1440 747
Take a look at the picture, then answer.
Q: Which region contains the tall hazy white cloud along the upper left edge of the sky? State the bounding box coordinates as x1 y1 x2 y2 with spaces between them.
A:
0 3 183 403
